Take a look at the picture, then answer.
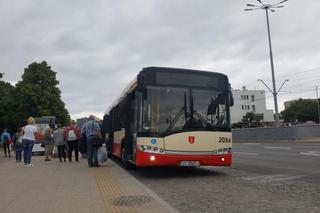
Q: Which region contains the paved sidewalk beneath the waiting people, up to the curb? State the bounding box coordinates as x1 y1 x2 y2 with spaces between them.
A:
0 153 175 213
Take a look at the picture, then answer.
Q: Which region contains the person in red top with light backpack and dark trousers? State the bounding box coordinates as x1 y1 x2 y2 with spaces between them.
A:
63 120 80 162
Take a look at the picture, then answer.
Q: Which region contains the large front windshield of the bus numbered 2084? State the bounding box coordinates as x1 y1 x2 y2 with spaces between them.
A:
142 86 229 135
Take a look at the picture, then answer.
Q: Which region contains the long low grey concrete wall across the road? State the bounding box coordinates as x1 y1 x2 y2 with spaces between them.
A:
232 125 320 142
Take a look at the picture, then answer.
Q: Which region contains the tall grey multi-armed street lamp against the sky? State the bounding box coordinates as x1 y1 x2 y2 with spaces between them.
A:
244 0 288 126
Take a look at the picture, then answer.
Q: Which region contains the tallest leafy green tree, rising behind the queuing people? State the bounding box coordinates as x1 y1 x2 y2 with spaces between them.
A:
13 61 70 125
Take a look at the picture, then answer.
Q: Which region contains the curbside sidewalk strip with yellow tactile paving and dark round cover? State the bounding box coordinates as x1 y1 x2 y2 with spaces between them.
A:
94 162 169 213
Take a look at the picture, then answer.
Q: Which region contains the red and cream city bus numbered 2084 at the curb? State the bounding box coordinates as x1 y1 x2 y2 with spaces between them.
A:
102 67 233 169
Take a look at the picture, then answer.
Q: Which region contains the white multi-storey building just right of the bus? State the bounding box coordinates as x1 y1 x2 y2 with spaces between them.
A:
230 87 274 124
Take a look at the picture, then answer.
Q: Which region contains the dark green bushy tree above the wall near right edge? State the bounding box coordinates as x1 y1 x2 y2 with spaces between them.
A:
281 99 318 123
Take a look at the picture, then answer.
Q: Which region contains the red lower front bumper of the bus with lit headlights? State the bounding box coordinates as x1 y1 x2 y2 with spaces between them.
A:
136 150 232 167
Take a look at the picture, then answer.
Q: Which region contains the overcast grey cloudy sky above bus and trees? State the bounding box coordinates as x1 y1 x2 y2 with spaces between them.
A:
0 0 320 119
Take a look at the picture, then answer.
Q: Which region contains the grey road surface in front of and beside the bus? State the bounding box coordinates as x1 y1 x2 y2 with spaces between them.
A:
122 142 320 213
